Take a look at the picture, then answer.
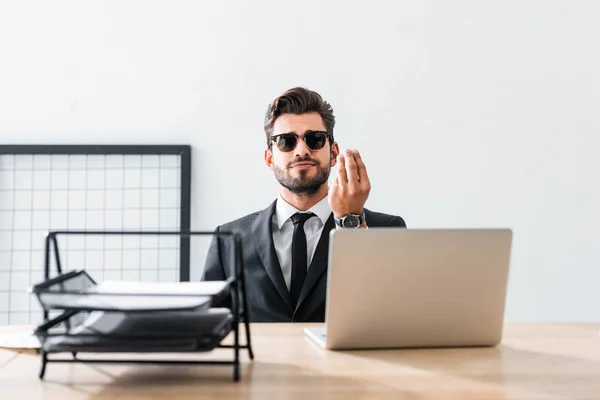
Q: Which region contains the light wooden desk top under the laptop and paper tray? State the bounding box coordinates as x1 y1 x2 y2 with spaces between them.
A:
0 323 600 400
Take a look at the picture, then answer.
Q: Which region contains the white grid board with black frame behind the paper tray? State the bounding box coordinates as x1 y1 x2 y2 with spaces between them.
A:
0 145 191 325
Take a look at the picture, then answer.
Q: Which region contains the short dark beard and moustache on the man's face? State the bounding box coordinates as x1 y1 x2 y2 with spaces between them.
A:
273 157 331 196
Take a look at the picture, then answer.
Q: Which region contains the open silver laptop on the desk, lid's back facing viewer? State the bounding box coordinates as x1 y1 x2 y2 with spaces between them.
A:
305 228 512 350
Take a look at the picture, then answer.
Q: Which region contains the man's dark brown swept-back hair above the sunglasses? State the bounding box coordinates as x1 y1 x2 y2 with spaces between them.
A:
265 87 335 147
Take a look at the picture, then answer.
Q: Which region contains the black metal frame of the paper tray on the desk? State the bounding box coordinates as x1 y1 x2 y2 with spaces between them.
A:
35 230 254 382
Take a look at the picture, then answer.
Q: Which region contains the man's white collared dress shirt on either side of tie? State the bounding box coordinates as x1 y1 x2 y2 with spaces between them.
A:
271 195 331 290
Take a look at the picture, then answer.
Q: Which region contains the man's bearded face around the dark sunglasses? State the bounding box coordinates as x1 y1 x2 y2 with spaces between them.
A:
265 112 339 195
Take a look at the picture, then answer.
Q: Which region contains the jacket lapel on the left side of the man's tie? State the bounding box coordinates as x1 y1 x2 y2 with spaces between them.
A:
252 201 292 311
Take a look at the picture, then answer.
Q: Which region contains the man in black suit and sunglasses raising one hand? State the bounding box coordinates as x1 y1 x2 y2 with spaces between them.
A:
203 88 406 322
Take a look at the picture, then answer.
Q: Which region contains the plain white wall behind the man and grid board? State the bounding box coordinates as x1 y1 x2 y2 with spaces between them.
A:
0 0 600 321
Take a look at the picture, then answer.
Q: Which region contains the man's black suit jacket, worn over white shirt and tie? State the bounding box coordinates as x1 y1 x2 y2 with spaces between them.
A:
202 202 406 322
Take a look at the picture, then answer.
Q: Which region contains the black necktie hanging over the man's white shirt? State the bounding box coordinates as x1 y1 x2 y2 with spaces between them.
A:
290 213 315 309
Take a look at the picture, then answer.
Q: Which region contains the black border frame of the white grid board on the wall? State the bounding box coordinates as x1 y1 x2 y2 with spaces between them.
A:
0 144 192 282
